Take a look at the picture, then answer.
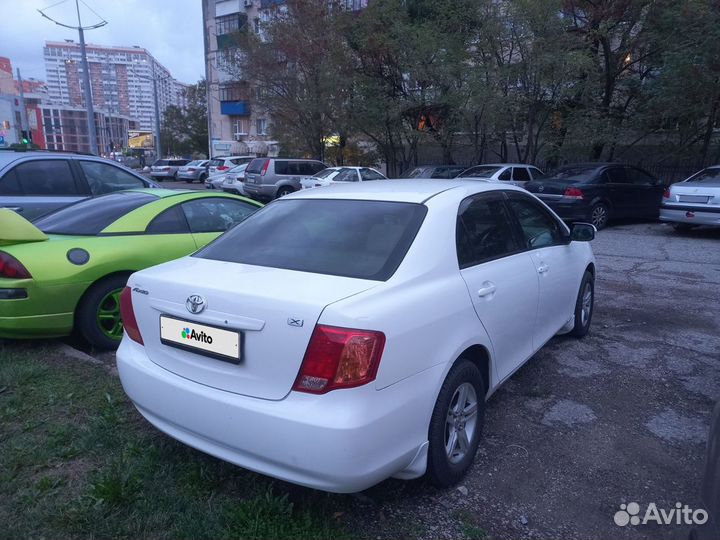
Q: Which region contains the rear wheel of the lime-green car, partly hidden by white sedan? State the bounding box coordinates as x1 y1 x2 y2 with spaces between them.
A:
76 274 128 349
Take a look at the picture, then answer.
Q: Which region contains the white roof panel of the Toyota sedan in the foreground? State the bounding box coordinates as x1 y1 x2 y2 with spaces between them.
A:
283 178 525 204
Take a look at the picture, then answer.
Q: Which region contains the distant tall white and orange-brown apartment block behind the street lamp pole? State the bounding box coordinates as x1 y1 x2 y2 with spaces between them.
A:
43 39 186 131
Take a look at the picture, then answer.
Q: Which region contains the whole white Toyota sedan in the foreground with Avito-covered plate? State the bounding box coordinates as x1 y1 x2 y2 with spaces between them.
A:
117 180 596 492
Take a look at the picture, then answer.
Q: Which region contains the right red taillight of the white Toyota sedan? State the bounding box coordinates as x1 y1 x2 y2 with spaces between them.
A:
293 324 385 394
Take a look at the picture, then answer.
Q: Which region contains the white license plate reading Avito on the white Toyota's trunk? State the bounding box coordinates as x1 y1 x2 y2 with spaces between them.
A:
160 315 242 364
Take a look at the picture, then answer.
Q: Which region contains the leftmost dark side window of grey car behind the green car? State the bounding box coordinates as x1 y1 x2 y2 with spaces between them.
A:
14 159 86 196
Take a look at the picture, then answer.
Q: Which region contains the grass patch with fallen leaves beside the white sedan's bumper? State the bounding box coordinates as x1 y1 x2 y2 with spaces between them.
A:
0 343 347 539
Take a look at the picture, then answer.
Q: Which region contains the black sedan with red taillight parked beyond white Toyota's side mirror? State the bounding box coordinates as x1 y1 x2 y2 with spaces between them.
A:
524 163 664 229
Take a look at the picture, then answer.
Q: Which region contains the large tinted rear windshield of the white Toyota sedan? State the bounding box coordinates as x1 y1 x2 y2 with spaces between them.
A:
194 199 427 281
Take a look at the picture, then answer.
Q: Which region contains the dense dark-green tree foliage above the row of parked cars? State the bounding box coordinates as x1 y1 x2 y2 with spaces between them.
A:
224 0 720 170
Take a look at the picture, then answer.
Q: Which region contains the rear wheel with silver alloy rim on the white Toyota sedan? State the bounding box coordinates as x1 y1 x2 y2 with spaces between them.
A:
427 358 485 488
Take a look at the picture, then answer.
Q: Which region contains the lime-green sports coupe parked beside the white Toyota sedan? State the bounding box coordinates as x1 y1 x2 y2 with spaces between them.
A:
0 189 262 349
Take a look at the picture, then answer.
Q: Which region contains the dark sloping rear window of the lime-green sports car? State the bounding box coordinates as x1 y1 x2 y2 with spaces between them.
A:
33 191 157 236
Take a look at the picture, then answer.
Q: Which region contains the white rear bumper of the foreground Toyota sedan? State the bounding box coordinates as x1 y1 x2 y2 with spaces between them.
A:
117 337 443 493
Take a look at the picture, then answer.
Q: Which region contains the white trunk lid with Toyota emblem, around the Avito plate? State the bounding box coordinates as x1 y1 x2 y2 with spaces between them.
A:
129 257 378 400
